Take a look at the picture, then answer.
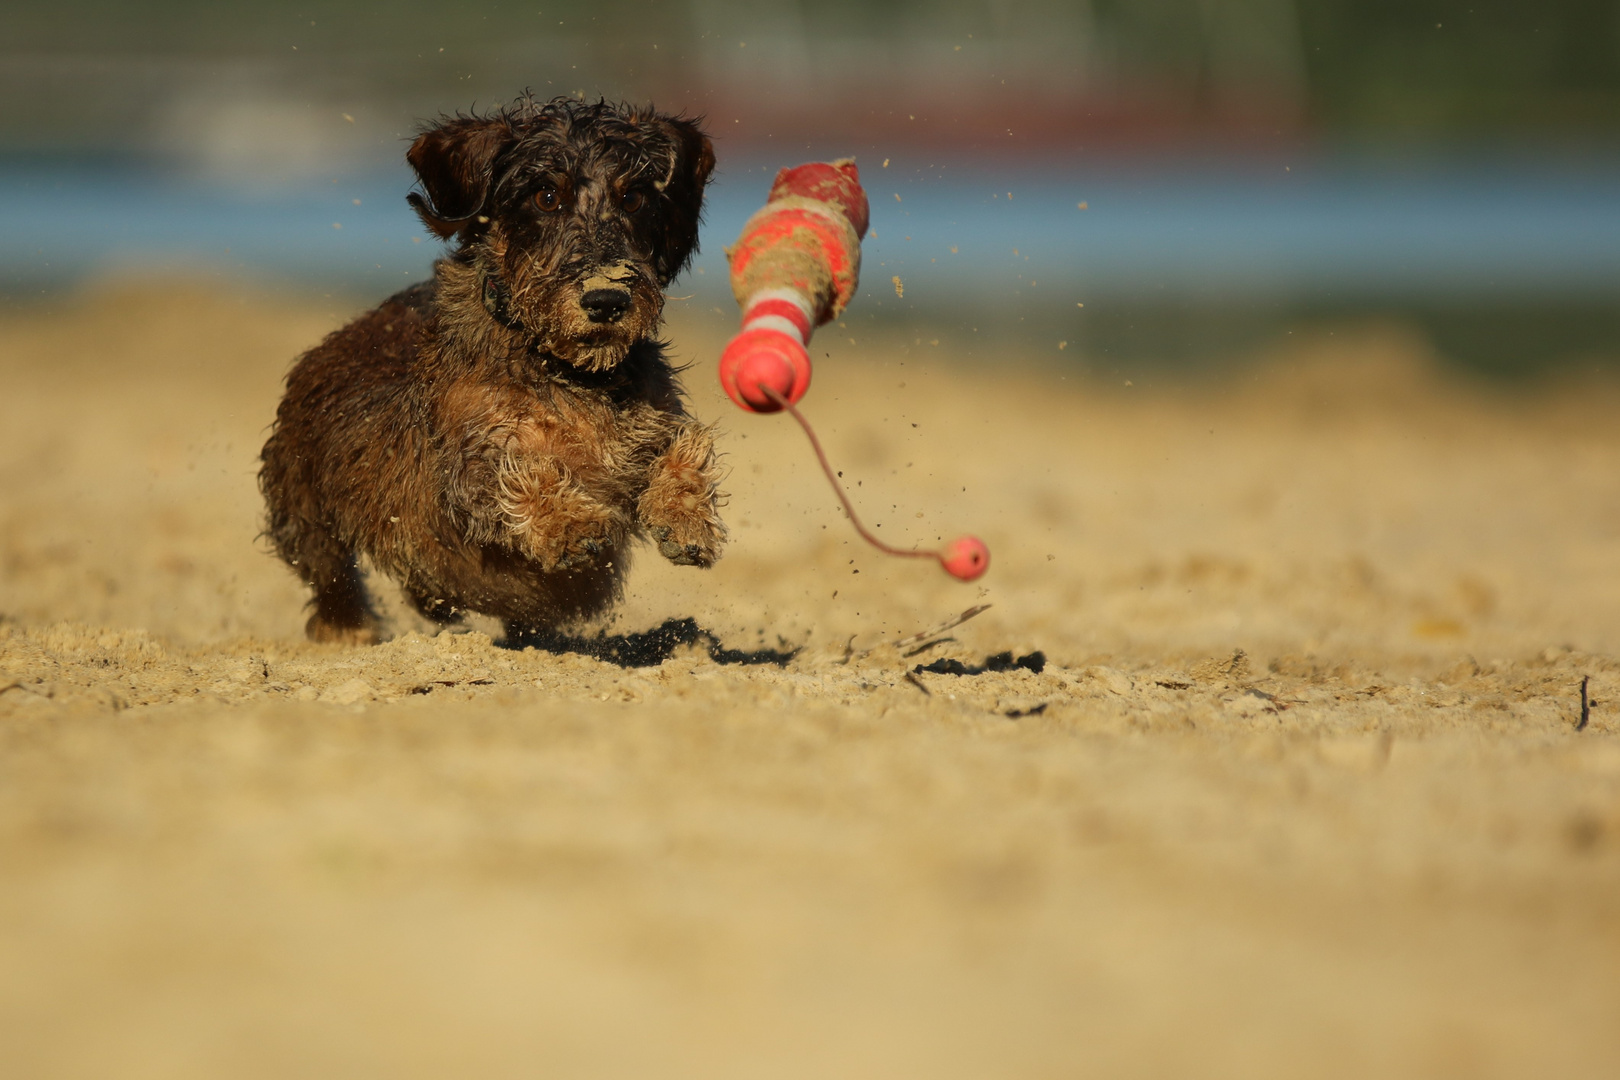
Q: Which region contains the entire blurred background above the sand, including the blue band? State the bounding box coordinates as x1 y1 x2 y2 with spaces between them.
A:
0 0 1620 379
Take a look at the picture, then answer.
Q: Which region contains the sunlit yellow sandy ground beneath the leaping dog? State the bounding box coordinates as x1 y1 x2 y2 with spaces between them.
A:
0 285 1620 1078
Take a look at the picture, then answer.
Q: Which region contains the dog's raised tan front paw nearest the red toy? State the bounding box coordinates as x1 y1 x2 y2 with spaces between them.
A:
637 421 726 567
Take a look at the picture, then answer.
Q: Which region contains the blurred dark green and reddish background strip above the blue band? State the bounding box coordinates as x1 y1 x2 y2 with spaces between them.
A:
9 0 1620 152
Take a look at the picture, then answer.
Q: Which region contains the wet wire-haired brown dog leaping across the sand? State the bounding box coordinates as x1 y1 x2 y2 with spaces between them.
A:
259 97 726 643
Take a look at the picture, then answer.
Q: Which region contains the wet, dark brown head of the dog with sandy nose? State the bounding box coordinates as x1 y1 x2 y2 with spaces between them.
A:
407 97 714 371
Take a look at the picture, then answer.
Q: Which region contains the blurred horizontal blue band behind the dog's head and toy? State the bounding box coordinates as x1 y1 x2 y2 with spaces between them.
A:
0 157 1620 308
